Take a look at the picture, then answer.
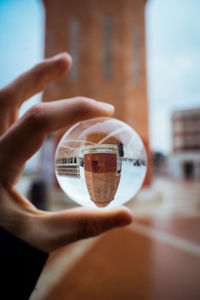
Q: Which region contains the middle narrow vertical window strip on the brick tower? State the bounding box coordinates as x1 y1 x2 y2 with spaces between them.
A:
103 17 113 79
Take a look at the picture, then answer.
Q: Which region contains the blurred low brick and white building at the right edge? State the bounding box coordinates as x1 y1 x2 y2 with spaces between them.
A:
169 109 200 178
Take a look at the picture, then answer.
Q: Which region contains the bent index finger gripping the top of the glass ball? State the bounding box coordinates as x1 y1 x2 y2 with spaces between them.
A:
0 97 114 184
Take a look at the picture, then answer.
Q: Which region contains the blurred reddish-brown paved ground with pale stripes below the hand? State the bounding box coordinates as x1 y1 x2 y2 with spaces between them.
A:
31 179 200 300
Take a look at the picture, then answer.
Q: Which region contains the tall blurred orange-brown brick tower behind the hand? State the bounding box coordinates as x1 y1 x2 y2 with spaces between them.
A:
43 0 150 183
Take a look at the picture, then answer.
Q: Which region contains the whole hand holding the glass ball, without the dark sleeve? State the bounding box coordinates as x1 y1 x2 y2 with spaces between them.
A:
0 53 132 252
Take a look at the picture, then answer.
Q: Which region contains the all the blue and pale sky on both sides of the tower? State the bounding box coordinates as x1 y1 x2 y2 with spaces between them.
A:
0 0 200 154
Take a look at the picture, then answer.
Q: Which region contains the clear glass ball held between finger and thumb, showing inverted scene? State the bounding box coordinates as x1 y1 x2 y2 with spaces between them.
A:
55 117 147 209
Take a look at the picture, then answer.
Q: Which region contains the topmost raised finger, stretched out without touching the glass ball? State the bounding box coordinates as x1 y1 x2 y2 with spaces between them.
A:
0 53 72 106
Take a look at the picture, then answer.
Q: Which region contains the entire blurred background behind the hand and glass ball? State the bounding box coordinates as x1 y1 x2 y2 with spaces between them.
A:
0 0 200 300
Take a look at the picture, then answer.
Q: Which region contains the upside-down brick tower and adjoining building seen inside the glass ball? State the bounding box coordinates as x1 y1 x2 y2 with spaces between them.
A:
56 144 124 207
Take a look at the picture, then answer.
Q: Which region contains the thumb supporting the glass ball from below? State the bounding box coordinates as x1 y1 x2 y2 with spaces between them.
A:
38 207 133 252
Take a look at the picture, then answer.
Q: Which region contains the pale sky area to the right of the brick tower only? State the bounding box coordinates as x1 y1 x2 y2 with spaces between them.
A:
146 0 200 153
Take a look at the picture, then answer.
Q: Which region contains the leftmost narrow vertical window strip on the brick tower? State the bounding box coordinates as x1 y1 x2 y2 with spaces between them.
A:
68 18 80 82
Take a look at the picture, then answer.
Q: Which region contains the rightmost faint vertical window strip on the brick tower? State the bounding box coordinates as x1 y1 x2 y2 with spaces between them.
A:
132 27 141 87
